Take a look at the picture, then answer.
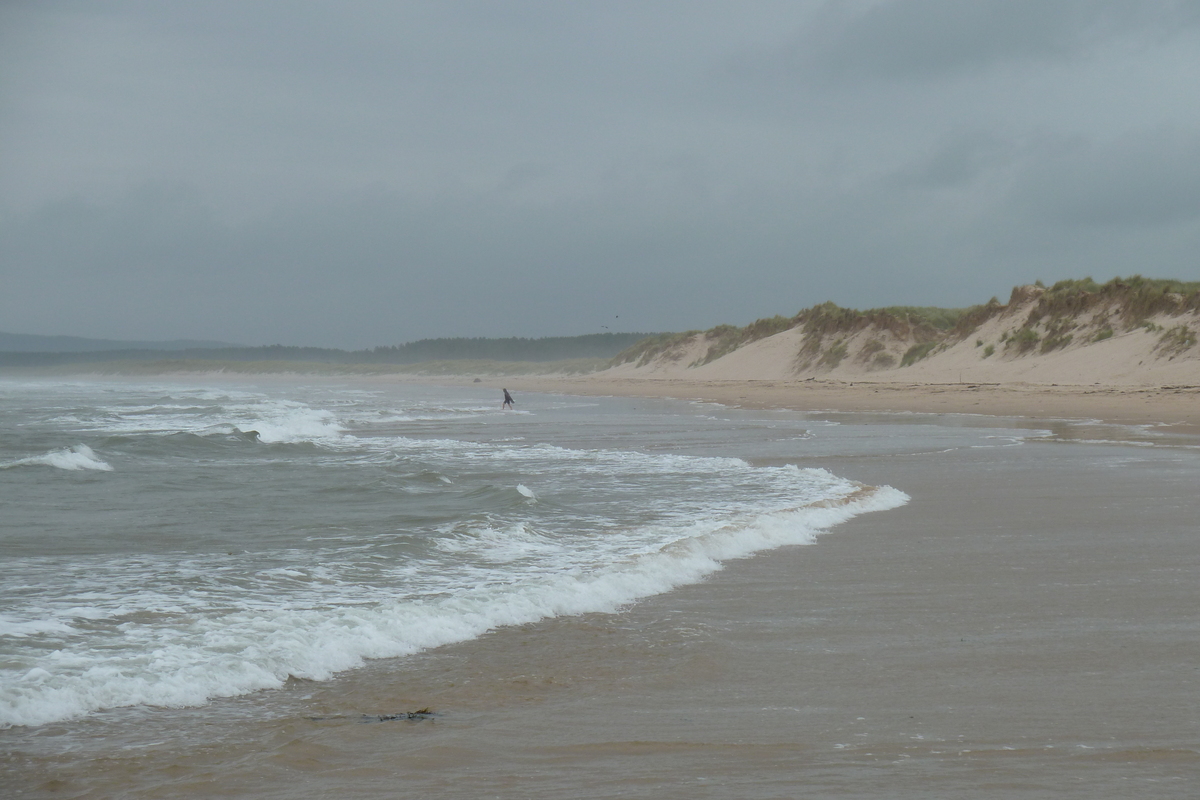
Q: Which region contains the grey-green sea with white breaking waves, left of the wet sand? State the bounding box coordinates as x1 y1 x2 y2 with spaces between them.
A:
0 381 906 727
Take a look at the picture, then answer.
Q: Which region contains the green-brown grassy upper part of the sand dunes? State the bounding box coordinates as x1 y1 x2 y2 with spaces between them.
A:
613 276 1200 375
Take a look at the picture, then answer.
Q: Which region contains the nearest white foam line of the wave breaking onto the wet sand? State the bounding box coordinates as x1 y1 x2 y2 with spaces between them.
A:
0 487 908 727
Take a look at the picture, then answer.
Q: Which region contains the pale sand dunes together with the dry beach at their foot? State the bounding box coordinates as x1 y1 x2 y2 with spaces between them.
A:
524 284 1200 432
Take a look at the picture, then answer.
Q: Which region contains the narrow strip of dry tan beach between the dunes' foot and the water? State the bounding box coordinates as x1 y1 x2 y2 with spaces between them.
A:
11 362 1200 435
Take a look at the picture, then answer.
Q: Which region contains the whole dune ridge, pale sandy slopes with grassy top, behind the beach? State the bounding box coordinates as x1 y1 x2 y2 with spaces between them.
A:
601 278 1200 386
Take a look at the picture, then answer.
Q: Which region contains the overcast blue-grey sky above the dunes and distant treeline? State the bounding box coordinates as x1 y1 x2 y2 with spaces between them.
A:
0 0 1200 348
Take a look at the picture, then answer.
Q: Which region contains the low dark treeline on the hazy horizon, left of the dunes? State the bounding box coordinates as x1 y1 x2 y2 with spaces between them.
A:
0 333 650 367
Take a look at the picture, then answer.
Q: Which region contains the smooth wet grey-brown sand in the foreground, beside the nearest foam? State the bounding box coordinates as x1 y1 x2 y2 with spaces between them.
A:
11 407 1200 799
